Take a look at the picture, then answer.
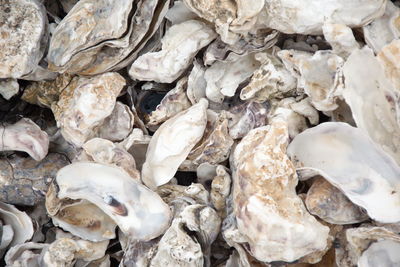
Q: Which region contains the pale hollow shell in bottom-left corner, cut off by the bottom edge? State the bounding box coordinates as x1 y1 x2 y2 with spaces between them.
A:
4 242 49 267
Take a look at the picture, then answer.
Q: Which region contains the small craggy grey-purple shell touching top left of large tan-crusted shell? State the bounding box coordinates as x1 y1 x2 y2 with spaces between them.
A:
228 101 267 139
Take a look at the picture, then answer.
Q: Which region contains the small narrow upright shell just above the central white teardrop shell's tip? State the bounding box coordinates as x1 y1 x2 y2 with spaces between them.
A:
186 60 207 105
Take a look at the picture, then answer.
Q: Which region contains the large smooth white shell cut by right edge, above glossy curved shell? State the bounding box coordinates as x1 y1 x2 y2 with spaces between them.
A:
343 47 400 163
